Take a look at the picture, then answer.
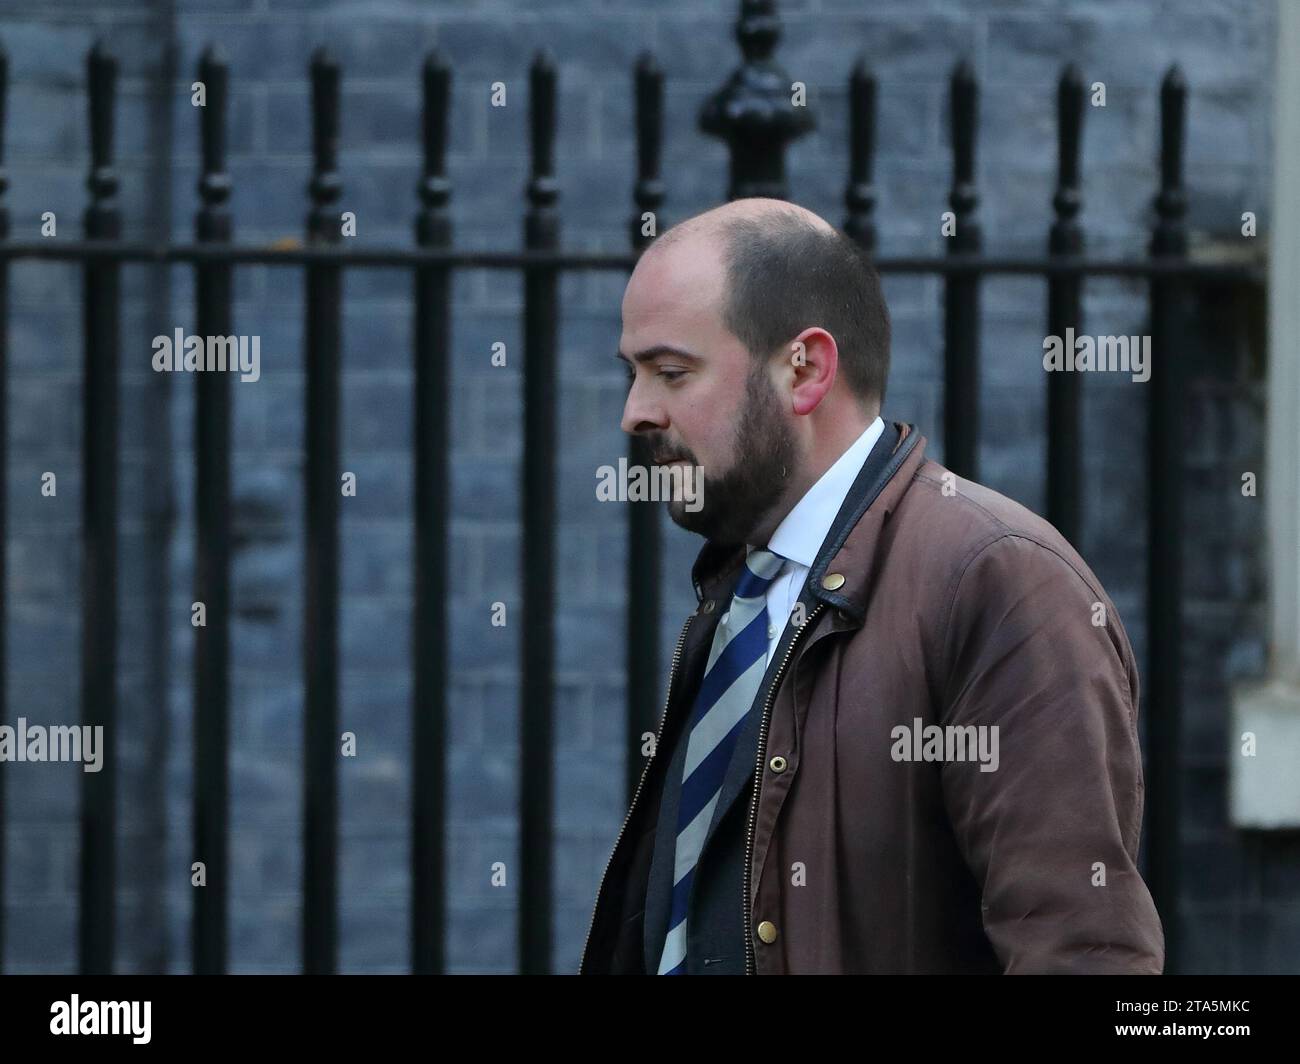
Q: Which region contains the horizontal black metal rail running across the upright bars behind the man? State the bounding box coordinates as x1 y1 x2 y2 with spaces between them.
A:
0 241 1268 284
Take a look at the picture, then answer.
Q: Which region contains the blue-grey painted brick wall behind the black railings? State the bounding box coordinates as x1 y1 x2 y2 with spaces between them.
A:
0 0 1300 972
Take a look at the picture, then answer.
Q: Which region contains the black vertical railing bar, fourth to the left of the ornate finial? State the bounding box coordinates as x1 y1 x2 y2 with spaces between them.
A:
303 47 342 974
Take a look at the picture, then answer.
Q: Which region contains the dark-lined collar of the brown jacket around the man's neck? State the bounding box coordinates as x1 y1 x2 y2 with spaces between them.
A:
690 421 926 623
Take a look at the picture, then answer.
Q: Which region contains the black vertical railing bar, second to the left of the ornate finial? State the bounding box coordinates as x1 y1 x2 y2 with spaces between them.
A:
519 48 560 974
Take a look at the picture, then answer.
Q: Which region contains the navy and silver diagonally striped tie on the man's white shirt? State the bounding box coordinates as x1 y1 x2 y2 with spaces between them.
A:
659 548 785 976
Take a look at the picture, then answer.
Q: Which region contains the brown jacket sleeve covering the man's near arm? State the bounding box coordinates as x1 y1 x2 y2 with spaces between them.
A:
939 535 1165 974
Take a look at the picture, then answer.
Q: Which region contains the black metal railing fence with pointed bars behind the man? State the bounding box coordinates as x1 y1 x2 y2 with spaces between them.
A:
0 0 1262 973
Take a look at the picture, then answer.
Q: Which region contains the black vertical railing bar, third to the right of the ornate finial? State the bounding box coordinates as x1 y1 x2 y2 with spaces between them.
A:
1047 62 1083 546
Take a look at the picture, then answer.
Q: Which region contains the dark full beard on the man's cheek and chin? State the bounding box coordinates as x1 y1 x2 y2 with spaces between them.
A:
668 364 794 544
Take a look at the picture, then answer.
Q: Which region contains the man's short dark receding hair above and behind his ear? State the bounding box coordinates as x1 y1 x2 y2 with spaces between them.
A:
664 209 891 406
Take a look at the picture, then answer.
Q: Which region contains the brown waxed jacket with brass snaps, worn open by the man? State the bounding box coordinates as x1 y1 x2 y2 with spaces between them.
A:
580 423 1165 974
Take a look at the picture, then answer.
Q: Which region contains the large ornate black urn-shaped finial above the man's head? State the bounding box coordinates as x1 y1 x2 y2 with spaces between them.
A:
699 0 816 199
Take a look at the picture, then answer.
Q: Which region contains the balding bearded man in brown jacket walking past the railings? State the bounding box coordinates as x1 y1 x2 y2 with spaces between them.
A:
580 199 1164 974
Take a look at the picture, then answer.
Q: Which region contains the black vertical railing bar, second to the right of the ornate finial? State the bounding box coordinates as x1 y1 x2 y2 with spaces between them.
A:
944 61 982 480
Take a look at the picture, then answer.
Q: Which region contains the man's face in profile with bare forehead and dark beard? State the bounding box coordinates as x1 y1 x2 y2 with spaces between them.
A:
619 241 797 544
